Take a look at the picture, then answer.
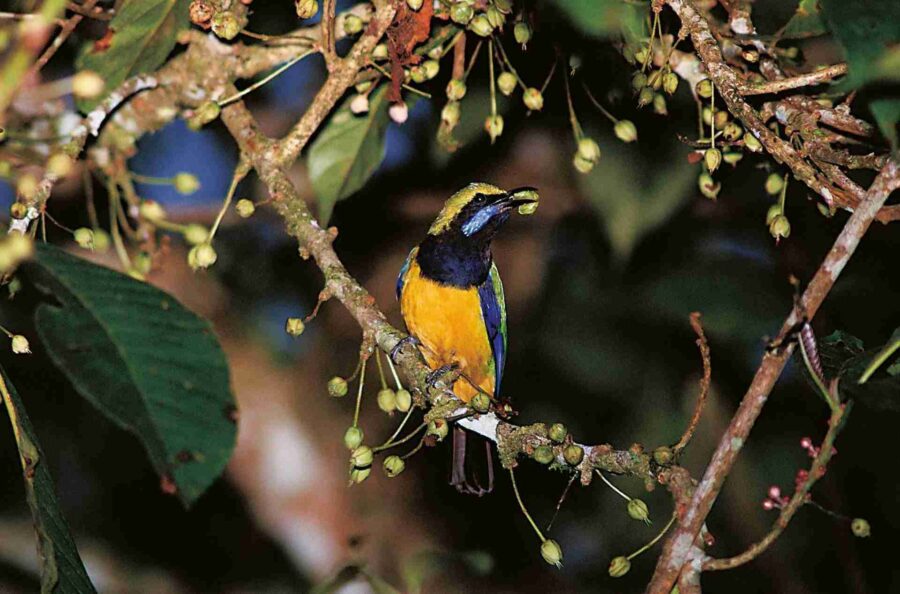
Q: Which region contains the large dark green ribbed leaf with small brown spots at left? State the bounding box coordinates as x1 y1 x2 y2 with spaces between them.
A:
27 244 236 505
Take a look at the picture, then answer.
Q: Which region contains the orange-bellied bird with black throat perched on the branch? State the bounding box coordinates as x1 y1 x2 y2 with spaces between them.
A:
397 183 537 496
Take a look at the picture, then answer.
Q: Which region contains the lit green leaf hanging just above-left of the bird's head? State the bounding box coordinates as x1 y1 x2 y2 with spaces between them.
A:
306 85 390 224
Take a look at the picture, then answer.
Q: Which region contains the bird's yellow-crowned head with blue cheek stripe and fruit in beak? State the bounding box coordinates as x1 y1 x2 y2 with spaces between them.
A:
428 183 537 244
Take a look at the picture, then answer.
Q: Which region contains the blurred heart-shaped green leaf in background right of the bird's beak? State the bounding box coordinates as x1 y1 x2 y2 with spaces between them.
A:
578 142 696 264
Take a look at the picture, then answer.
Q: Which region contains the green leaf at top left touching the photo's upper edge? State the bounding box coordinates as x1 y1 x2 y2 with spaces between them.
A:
75 0 190 112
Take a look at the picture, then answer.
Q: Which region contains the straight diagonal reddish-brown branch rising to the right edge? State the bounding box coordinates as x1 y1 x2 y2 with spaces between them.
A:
647 159 900 594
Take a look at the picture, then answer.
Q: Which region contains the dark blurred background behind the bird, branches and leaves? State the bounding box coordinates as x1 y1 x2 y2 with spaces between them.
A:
0 1 900 593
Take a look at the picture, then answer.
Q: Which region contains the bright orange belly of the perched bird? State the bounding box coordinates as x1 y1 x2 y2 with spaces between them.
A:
400 261 494 402
